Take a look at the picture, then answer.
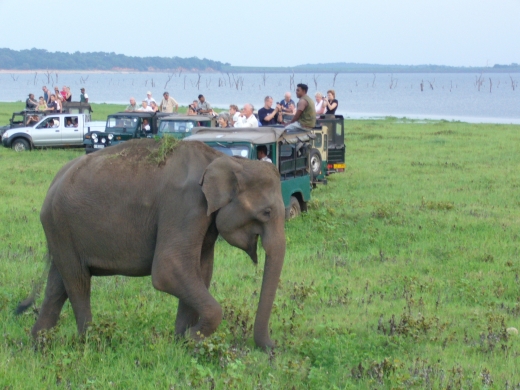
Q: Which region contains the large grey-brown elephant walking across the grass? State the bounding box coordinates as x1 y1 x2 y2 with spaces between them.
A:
17 139 286 350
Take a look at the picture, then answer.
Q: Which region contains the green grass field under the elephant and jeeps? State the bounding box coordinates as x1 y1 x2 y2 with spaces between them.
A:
0 104 520 389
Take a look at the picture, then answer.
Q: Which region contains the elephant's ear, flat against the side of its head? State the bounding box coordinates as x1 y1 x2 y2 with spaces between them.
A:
199 156 243 216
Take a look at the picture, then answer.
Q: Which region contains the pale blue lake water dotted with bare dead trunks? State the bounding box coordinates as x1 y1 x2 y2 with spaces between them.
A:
0 72 520 124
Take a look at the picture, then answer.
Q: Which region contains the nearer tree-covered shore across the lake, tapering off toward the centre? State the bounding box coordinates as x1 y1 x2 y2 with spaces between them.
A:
0 49 229 71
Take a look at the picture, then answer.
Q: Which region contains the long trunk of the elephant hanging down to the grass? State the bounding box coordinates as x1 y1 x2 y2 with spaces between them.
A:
254 222 285 350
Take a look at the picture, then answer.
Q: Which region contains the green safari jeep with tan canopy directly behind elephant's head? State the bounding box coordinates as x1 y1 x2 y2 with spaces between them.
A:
184 127 314 219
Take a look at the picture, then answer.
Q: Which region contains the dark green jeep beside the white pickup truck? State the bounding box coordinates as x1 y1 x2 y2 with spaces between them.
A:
83 111 171 154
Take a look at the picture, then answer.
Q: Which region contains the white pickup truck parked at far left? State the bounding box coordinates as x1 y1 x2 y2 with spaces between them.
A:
2 113 105 152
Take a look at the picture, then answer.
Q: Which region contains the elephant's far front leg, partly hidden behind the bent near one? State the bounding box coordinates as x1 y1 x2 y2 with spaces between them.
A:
175 225 218 335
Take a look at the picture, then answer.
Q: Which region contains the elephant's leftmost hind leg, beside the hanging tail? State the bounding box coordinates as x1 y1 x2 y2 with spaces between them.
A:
31 263 67 337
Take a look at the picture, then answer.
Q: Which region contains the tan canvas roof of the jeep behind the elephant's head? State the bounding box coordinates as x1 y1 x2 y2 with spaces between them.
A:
189 127 314 145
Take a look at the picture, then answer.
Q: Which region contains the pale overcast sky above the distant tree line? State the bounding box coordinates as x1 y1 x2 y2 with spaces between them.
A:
0 0 520 66
